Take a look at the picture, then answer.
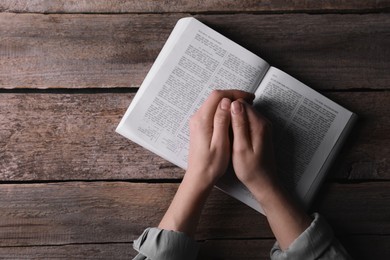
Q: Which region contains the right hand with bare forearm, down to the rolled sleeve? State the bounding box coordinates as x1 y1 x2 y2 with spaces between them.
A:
231 101 311 250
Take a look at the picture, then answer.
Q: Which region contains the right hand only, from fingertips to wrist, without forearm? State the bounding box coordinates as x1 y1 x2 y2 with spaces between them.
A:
231 100 279 203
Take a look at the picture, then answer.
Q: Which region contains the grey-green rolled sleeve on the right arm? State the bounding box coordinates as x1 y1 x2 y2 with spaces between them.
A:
270 213 352 260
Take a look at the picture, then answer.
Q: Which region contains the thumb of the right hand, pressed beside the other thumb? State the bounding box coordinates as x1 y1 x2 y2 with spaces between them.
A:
231 100 252 151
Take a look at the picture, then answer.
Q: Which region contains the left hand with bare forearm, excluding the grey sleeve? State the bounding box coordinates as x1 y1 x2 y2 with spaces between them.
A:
159 90 254 236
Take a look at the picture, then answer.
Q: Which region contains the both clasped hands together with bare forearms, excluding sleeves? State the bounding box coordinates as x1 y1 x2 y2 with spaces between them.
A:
159 90 311 244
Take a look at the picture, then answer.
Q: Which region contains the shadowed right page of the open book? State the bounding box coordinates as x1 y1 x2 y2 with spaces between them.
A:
254 67 353 203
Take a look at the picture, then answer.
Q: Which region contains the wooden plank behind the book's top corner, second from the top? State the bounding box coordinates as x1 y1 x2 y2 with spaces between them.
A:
0 13 390 89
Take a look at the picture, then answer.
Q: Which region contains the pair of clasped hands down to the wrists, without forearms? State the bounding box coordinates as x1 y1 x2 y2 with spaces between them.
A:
186 90 275 199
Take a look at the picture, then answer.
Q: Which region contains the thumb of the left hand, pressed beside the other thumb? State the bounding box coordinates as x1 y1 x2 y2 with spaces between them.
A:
211 98 231 147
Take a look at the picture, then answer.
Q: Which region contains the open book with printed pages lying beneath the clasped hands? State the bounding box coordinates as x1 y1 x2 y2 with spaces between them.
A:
116 18 356 214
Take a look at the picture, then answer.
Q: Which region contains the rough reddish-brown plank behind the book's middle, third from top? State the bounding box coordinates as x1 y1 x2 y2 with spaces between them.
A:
0 92 390 181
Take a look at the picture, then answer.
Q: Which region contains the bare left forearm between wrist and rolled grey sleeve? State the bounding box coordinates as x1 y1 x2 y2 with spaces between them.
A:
158 172 213 236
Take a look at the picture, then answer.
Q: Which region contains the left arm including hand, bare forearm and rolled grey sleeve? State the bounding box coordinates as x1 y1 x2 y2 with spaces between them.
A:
133 90 254 260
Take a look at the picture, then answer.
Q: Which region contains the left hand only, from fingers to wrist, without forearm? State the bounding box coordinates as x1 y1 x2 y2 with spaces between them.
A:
186 90 254 186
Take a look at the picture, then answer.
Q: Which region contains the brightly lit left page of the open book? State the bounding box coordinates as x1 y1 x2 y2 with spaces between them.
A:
117 18 269 169
